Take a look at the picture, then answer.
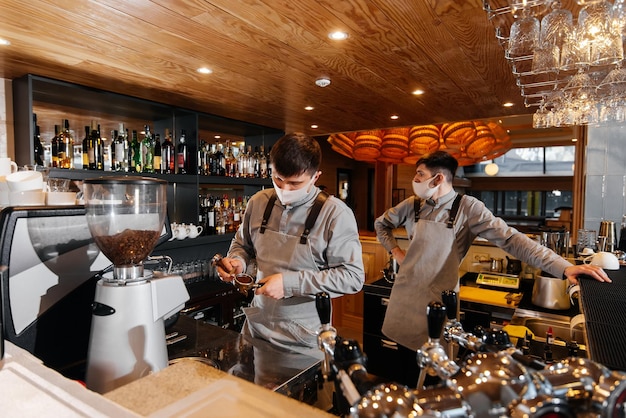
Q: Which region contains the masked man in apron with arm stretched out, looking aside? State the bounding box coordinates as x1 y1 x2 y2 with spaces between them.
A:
374 151 610 386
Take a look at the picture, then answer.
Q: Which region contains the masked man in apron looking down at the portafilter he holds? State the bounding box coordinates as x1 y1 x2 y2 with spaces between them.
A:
218 133 365 358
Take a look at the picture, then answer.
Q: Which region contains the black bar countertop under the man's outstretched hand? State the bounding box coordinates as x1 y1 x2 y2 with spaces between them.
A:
580 266 626 371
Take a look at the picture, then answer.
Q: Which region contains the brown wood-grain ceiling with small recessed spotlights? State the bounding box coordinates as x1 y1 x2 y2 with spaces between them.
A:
0 0 548 135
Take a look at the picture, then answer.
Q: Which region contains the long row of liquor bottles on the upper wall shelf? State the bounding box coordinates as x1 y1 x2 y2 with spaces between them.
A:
33 114 270 184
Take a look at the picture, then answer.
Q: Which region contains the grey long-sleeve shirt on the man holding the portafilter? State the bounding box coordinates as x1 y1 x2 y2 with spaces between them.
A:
228 188 365 298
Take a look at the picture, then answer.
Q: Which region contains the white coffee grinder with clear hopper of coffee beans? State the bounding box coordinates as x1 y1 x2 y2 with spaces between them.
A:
83 177 189 393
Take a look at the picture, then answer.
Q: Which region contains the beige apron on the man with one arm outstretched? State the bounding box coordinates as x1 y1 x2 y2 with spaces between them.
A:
382 196 461 351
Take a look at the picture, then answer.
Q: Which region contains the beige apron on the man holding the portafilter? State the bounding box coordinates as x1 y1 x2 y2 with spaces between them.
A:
242 193 323 358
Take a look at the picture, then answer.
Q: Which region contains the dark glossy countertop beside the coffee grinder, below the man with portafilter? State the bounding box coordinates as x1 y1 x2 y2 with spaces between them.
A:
166 315 320 402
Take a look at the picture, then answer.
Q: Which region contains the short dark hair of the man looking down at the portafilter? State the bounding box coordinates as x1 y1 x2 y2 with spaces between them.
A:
270 132 322 177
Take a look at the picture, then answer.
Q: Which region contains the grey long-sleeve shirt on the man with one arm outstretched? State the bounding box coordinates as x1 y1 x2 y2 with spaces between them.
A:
374 190 572 278
